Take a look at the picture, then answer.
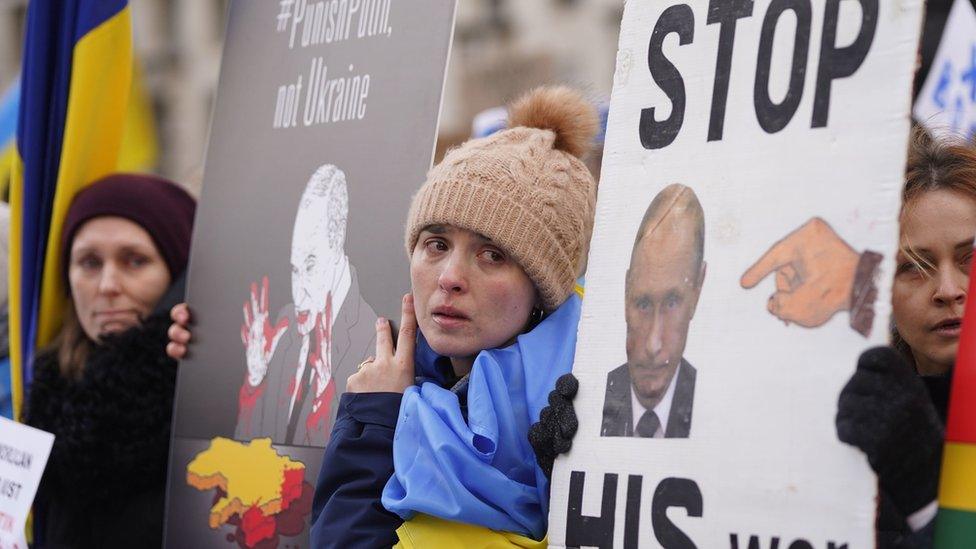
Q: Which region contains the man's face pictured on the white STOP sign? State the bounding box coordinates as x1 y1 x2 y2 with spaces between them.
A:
625 184 705 409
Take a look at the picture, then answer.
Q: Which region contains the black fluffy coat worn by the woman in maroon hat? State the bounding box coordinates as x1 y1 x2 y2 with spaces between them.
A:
25 313 176 549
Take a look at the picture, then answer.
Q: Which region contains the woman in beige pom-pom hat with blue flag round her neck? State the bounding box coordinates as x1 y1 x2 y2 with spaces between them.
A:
171 87 598 547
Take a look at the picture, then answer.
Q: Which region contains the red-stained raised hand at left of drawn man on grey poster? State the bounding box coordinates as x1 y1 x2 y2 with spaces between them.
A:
241 276 288 387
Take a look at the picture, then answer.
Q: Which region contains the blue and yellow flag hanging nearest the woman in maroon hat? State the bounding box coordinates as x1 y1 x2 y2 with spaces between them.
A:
9 0 134 417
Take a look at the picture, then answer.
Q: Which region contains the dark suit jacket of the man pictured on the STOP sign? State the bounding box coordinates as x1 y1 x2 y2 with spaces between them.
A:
600 358 696 438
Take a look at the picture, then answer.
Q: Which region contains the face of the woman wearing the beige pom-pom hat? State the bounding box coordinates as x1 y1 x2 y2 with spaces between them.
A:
410 225 536 368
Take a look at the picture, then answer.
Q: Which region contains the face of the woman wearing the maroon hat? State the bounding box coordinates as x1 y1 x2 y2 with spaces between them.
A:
68 217 170 341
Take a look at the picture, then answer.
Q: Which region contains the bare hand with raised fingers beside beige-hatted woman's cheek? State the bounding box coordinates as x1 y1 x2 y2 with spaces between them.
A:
346 294 417 393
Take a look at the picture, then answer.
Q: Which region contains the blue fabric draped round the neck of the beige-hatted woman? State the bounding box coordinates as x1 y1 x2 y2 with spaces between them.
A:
383 294 581 541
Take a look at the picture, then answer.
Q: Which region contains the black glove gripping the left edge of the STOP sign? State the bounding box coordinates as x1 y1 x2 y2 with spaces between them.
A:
529 374 579 478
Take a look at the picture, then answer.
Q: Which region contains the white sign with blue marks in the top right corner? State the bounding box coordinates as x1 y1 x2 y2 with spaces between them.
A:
914 0 976 138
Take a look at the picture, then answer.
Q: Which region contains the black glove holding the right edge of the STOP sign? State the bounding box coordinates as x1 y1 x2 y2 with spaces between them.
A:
836 347 944 516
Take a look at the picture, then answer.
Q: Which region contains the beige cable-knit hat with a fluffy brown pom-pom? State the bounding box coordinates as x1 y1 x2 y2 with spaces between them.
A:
406 86 599 311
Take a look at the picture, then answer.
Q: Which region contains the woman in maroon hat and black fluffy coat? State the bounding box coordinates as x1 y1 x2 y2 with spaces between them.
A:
24 174 196 548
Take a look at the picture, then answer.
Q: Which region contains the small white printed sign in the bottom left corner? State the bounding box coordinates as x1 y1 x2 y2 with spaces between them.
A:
0 417 54 549
